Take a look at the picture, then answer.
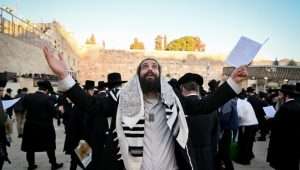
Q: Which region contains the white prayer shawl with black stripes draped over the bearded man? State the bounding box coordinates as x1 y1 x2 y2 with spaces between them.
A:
116 75 188 170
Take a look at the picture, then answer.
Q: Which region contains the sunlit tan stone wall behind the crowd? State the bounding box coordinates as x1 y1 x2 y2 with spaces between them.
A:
79 48 224 87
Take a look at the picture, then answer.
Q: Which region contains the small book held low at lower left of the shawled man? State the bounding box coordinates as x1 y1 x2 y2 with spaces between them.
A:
74 140 92 168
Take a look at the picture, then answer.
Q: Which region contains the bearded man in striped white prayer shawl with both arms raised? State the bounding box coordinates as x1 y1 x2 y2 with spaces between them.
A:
44 44 248 170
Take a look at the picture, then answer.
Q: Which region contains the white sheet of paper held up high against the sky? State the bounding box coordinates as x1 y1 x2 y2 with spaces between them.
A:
225 36 268 67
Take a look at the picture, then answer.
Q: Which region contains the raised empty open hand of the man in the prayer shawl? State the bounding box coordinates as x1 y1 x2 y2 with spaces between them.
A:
43 47 68 80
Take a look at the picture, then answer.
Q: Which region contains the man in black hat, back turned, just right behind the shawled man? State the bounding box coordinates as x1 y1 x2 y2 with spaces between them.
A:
178 73 218 170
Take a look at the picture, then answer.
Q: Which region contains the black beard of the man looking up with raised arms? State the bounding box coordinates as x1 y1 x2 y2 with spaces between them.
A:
139 77 160 94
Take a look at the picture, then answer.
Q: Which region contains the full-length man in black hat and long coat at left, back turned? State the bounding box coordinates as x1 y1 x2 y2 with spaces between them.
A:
21 81 63 170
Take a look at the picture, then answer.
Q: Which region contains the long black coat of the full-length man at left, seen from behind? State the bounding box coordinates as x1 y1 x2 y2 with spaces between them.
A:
21 91 56 152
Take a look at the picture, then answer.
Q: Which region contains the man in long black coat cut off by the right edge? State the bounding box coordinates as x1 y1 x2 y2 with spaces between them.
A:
267 85 300 170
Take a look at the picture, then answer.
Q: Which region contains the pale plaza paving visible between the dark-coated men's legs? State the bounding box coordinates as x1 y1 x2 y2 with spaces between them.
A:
3 119 272 170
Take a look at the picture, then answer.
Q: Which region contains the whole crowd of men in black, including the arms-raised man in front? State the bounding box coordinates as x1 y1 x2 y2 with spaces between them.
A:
0 48 300 170
